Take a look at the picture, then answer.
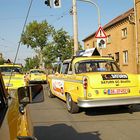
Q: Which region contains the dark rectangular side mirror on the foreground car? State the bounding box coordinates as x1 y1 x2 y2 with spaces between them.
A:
18 84 44 105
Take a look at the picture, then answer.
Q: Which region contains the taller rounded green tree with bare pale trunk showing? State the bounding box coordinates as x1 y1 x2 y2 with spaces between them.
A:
21 20 53 65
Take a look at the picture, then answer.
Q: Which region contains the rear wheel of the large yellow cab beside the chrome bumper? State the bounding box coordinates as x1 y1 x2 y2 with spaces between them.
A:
66 94 79 114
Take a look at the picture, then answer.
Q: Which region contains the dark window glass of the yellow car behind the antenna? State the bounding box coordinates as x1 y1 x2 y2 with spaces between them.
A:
0 66 23 73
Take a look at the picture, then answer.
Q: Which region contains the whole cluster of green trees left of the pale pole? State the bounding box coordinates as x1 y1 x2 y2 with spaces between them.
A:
21 21 82 69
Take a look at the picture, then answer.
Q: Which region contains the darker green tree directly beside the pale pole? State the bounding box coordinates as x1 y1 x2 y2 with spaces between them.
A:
43 28 81 64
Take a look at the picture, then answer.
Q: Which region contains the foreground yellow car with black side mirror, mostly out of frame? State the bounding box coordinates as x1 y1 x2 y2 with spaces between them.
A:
0 73 44 140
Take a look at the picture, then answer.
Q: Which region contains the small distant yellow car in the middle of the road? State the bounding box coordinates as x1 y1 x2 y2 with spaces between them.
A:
26 69 47 84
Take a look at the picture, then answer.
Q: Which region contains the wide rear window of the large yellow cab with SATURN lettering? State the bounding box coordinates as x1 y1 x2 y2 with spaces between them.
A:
75 60 120 74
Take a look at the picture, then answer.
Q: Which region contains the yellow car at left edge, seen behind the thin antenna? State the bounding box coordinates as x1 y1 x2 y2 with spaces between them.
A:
0 63 25 90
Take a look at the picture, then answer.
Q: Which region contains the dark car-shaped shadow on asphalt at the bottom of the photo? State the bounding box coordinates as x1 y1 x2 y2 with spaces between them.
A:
34 124 101 140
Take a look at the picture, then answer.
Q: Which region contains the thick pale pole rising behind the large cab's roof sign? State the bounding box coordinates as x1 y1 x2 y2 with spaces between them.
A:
72 0 78 55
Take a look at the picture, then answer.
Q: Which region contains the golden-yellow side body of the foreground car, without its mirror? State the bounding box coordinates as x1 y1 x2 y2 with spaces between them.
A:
0 73 31 140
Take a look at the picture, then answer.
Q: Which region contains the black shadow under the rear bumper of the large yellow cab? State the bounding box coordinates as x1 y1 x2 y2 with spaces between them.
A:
83 105 140 116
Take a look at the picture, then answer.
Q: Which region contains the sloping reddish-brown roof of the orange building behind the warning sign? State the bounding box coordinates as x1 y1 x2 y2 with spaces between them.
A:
82 8 134 41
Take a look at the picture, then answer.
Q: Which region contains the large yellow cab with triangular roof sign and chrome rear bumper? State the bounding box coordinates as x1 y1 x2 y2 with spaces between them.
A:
48 48 140 113
